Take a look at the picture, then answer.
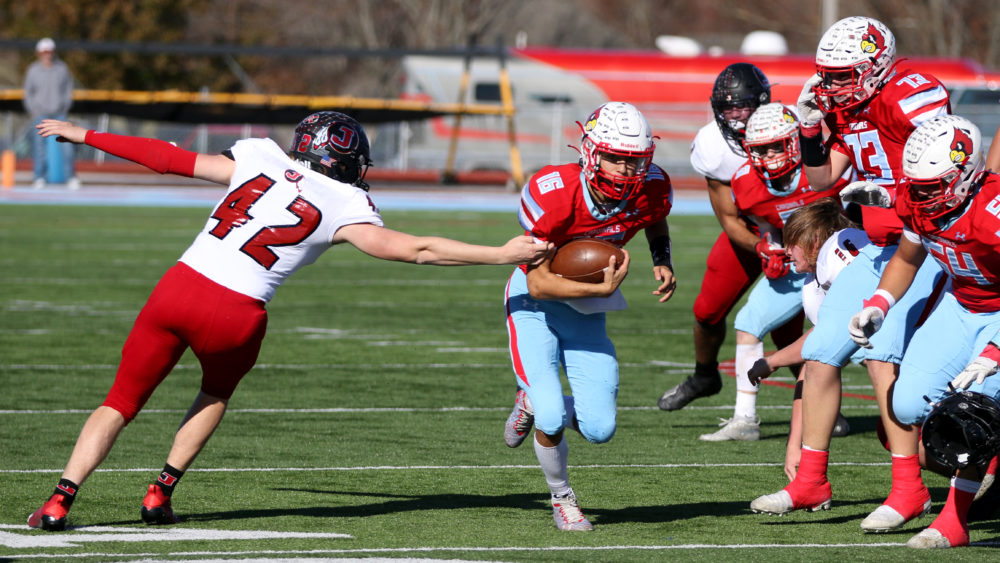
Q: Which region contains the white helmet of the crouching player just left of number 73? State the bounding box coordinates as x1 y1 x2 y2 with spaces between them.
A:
743 103 802 180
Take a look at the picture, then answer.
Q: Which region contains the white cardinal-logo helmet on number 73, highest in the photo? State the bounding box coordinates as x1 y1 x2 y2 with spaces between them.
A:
814 16 896 112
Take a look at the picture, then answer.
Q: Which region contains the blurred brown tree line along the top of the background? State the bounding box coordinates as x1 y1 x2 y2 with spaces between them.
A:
0 0 1000 97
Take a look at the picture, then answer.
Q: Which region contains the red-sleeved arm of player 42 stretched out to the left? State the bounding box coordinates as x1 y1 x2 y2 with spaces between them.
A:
36 119 236 185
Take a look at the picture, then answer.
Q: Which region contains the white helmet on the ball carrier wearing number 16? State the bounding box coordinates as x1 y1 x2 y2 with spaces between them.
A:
577 102 656 201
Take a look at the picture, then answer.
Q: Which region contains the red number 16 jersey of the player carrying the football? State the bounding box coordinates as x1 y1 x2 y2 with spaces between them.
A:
518 164 674 268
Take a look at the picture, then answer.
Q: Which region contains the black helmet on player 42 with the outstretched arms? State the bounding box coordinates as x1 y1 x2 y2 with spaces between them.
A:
288 111 371 191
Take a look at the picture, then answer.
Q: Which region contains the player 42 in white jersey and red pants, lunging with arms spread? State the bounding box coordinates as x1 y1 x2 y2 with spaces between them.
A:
28 111 552 531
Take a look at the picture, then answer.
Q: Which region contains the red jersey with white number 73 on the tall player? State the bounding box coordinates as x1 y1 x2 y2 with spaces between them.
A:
827 69 951 246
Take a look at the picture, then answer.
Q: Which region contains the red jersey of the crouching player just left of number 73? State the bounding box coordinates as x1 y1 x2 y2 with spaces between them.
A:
732 161 847 244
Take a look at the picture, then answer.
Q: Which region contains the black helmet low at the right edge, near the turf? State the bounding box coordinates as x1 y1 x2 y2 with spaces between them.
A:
921 391 1000 469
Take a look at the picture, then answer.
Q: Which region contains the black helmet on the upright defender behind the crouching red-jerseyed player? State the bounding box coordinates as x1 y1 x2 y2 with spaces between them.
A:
711 63 771 156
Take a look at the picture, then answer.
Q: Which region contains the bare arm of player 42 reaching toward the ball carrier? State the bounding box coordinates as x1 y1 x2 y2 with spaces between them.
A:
333 223 553 266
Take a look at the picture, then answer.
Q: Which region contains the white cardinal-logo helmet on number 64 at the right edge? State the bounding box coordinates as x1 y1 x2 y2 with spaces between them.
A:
897 115 986 219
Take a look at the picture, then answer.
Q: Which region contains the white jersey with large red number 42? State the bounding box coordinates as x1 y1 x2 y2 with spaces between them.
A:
180 139 383 302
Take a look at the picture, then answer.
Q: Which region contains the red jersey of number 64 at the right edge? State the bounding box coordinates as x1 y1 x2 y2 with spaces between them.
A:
896 174 1000 313
